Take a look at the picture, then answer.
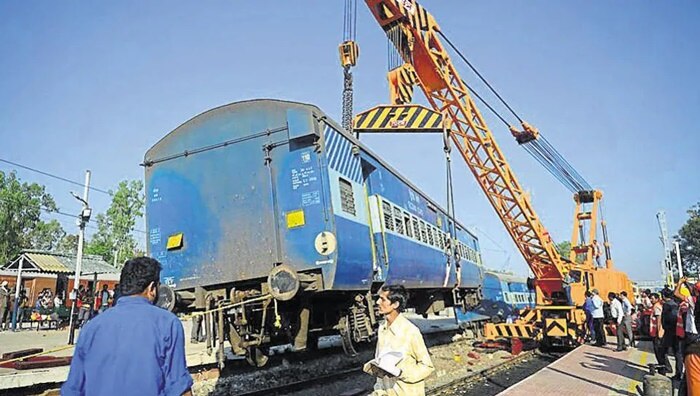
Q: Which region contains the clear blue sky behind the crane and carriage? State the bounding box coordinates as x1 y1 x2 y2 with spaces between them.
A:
0 0 700 279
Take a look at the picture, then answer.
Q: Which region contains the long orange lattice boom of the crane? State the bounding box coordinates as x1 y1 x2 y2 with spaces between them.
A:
365 0 565 284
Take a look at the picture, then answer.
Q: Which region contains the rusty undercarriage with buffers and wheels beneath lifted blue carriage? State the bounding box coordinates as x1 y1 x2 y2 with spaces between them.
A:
158 265 480 368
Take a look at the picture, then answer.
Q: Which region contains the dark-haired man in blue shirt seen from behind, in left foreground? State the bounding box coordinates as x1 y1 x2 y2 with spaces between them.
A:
61 257 192 396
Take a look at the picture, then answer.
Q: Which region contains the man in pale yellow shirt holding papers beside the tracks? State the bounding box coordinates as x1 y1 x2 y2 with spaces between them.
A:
364 285 435 396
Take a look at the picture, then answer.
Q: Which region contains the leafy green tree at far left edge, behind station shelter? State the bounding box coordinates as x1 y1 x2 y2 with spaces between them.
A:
0 171 65 263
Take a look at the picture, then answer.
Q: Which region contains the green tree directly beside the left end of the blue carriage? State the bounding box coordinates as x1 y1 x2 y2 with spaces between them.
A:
86 180 145 266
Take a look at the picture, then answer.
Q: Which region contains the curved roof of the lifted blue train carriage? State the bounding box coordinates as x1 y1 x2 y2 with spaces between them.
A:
144 99 478 240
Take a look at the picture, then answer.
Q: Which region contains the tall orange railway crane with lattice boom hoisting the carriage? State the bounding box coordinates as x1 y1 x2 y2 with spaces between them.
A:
355 0 632 345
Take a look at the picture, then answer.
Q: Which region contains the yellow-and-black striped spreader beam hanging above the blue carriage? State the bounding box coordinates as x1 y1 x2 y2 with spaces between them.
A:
353 104 442 133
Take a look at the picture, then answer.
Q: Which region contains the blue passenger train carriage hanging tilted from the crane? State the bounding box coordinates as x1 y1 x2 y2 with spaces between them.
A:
143 100 483 366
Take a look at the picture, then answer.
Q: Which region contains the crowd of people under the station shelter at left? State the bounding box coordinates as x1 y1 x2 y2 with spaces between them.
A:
0 280 119 331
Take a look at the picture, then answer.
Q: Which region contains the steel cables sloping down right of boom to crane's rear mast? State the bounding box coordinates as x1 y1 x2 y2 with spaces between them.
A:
438 31 592 193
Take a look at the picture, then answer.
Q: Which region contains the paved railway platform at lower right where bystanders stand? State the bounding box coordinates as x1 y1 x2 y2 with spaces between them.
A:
500 337 664 396
